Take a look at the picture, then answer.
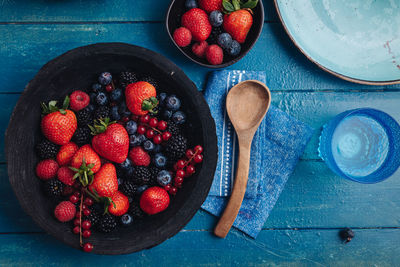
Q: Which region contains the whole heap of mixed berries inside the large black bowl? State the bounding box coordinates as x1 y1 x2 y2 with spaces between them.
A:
35 71 203 252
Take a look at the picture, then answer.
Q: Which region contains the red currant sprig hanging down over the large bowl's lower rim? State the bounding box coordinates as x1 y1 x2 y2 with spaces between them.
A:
69 191 93 252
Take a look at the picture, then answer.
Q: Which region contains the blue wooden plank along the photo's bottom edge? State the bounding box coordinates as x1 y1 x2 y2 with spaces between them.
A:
0 229 400 266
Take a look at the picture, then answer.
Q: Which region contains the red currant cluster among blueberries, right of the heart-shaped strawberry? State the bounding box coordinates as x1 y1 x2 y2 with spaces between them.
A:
137 115 172 145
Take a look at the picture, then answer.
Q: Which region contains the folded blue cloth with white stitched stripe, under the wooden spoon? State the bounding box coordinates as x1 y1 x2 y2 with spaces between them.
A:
202 70 313 238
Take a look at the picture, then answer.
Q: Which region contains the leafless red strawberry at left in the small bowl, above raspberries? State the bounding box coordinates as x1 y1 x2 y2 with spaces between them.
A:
181 8 212 42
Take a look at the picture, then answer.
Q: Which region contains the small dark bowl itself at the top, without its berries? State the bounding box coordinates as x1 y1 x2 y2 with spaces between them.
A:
165 0 264 69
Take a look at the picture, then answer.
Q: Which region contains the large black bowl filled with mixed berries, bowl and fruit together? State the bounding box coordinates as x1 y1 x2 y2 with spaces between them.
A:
6 43 217 254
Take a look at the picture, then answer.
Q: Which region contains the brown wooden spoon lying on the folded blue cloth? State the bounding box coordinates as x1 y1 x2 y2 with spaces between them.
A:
214 80 271 238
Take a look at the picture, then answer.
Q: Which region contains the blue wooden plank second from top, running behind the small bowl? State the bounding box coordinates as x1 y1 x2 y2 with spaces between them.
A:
0 23 400 95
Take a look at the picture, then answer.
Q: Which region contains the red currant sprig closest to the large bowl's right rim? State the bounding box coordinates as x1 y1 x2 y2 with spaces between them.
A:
164 145 203 195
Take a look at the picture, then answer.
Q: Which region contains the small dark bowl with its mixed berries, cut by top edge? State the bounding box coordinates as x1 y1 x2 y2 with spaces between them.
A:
166 0 264 68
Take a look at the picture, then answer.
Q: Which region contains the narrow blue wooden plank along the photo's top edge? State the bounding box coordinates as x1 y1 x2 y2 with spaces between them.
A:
0 0 278 23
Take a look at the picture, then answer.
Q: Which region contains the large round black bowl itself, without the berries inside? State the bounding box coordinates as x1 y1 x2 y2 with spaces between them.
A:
5 43 218 254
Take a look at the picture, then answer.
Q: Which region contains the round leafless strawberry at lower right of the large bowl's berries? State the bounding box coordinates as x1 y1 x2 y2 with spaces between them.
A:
140 186 169 215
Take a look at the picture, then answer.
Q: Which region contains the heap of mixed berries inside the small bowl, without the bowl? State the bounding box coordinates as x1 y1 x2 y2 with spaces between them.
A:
173 0 258 65
